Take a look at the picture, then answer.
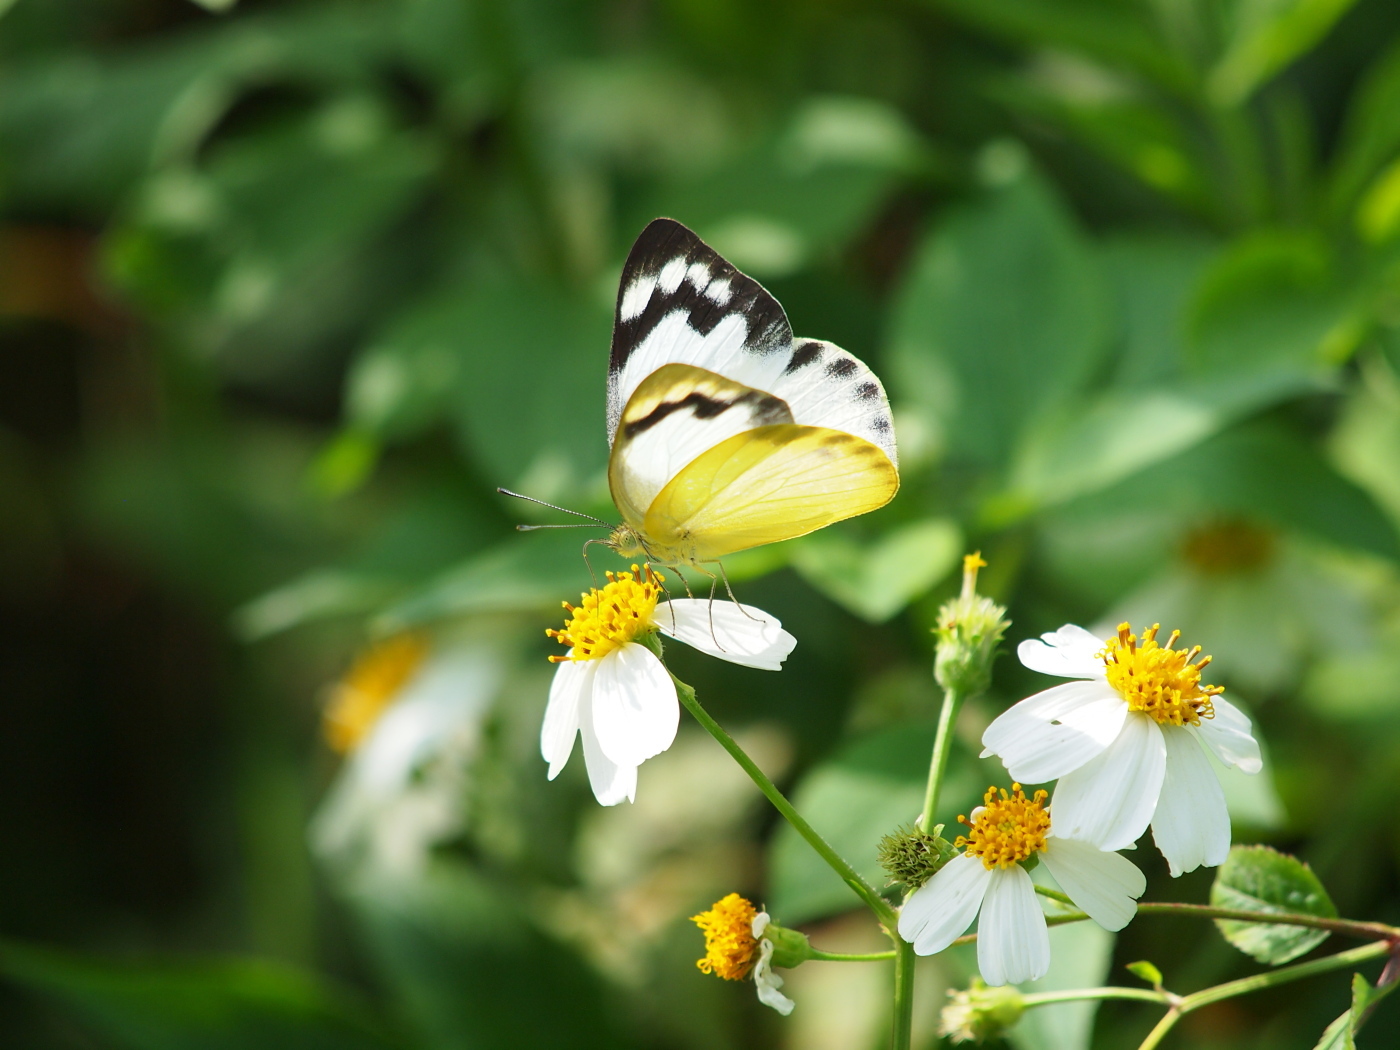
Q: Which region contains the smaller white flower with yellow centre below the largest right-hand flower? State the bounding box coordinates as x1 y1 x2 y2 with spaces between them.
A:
899 784 1147 986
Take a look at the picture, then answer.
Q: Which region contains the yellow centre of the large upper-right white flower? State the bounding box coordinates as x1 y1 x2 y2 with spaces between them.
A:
1099 623 1225 725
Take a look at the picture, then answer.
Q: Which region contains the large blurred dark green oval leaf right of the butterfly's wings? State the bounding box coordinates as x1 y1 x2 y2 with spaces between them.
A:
889 151 1107 466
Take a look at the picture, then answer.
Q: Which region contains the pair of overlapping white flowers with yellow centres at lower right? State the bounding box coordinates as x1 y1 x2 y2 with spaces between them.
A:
899 623 1261 986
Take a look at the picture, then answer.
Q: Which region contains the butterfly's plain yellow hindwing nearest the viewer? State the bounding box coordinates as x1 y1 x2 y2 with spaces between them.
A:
643 423 899 564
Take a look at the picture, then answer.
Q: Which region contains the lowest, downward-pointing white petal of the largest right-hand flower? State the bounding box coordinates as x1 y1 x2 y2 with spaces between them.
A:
1152 725 1229 878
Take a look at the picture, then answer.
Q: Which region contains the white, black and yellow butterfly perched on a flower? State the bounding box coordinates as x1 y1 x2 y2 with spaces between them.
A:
605 218 899 567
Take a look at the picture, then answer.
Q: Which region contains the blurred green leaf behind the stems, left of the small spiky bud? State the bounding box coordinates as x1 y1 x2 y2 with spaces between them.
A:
769 724 991 924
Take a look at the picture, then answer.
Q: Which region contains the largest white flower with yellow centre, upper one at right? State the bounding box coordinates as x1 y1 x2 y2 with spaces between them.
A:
981 623 1263 876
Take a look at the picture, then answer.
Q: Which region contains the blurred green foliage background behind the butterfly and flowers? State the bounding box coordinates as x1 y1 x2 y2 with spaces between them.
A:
0 0 1400 1050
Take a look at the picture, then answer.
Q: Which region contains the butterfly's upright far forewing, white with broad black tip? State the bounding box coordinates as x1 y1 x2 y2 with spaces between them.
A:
608 218 792 441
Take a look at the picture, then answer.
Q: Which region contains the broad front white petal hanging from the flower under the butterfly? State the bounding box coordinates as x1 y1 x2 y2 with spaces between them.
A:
592 643 680 766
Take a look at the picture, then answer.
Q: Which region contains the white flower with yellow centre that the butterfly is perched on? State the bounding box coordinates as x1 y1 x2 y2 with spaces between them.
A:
539 566 797 806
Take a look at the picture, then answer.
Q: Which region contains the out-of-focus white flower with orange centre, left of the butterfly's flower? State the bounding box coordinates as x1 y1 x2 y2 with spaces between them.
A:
311 638 504 878
